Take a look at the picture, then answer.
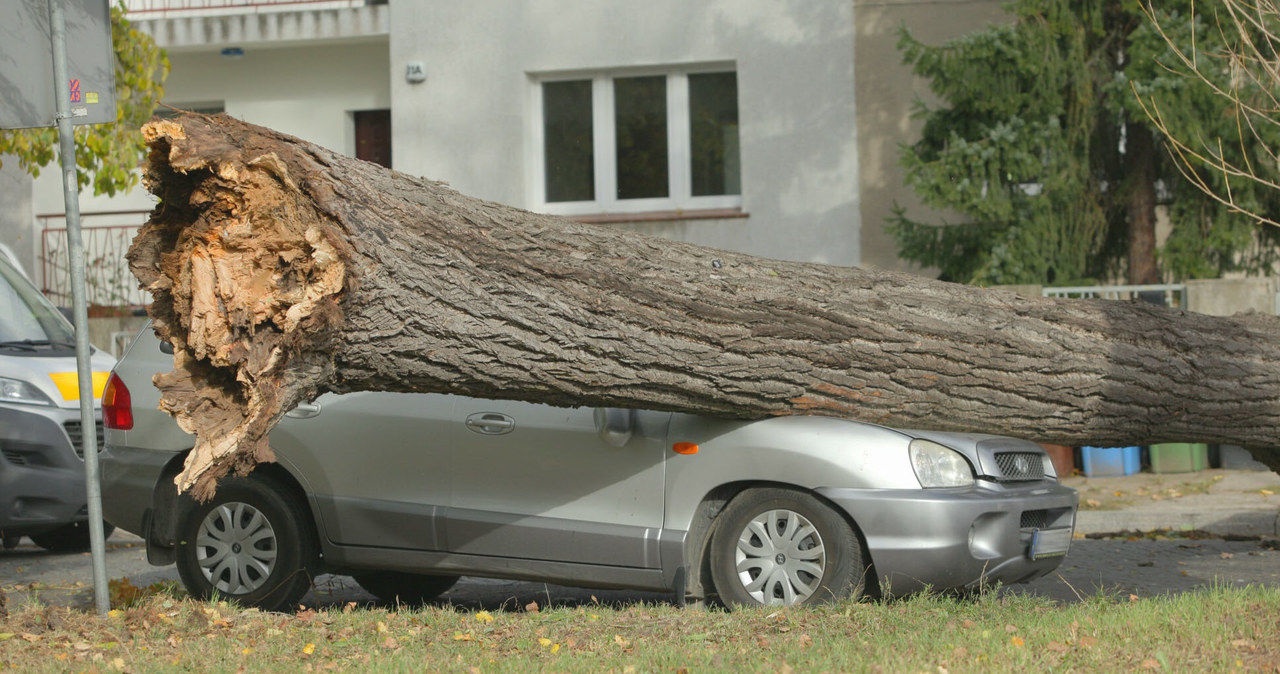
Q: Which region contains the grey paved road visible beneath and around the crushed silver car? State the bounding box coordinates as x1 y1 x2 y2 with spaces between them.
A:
0 532 1280 609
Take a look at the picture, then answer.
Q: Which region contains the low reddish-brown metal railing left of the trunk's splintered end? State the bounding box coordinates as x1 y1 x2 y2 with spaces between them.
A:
38 211 151 308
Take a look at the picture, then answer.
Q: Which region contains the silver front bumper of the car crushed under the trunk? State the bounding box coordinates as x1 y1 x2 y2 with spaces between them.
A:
817 482 1079 595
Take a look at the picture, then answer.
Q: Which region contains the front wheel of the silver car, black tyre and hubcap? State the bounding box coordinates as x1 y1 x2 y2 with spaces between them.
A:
710 489 864 606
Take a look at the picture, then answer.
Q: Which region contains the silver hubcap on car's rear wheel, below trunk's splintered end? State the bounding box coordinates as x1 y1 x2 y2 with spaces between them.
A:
196 503 276 595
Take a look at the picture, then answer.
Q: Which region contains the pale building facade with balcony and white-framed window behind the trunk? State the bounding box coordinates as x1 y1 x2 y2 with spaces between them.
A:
0 0 998 300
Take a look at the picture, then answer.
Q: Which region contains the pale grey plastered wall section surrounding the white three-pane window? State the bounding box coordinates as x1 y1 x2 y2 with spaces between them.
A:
390 0 860 265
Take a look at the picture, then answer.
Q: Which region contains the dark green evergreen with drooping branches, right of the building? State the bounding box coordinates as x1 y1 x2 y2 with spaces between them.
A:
890 0 1280 285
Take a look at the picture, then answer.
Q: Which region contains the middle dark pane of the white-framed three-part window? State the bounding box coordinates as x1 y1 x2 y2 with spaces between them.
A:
613 75 668 200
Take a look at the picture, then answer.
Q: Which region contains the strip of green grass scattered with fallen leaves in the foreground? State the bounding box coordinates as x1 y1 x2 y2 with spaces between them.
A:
0 588 1280 673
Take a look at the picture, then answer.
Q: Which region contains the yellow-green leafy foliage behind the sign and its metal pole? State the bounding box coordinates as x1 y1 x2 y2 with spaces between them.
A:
0 5 169 194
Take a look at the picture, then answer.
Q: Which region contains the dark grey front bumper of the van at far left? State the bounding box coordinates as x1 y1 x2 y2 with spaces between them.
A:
0 404 102 537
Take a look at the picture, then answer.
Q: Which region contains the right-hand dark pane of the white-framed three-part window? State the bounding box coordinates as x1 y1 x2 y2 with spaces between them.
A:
689 73 742 197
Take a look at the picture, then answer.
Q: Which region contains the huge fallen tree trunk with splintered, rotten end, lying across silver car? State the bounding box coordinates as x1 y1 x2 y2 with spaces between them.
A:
129 115 1280 496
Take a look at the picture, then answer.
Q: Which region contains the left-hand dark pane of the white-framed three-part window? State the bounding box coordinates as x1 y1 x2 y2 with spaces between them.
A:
543 79 595 202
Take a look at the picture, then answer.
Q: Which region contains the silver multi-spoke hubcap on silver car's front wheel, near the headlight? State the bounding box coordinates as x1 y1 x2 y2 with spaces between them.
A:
733 510 827 606
